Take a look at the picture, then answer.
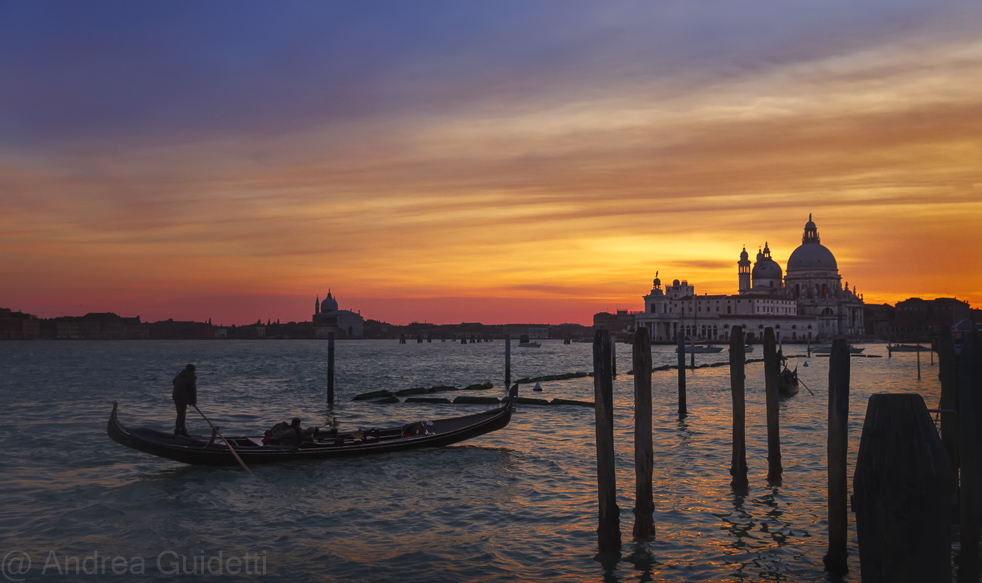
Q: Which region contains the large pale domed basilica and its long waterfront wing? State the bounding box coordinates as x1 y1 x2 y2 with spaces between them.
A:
635 215 863 342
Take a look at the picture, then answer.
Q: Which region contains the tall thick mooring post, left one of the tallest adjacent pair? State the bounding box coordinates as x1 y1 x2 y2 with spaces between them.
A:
593 329 621 553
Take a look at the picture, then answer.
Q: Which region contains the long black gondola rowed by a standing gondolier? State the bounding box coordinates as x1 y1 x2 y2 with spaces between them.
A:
106 389 517 466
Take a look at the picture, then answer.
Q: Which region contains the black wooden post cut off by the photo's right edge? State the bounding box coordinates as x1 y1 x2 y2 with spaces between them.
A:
958 332 982 583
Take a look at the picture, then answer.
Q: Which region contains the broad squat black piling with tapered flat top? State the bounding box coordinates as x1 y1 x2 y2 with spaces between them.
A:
853 393 954 583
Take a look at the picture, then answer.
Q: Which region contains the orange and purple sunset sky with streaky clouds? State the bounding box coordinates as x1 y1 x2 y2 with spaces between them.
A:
0 0 982 324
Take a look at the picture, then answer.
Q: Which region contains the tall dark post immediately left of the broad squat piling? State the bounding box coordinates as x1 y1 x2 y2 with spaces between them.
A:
824 338 850 575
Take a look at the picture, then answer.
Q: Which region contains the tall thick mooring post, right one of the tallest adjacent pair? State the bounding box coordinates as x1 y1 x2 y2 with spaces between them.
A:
633 326 655 539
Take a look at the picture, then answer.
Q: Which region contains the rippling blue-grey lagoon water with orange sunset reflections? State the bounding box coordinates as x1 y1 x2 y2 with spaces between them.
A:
0 340 940 583
